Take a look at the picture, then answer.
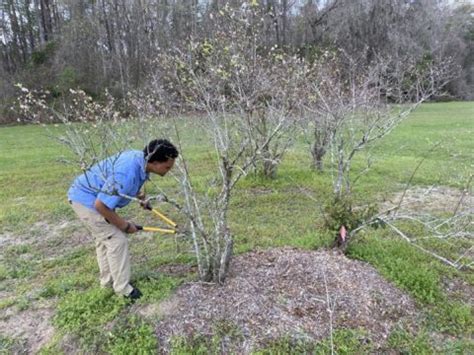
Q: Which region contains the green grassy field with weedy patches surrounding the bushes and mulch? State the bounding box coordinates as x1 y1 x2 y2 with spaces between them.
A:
0 102 474 354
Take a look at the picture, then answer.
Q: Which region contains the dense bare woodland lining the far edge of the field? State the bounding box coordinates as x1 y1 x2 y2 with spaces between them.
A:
0 0 474 121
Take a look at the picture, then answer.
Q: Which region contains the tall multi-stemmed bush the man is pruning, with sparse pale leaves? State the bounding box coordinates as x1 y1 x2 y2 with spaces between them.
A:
150 5 303 282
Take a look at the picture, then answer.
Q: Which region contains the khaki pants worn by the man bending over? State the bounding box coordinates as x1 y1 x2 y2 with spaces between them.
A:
71 202 133 296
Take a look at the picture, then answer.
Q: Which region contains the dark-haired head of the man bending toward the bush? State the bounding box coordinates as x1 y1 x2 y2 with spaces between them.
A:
143 139 179 176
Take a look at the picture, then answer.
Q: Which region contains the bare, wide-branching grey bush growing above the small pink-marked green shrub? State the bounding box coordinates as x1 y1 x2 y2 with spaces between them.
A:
305 52 456 197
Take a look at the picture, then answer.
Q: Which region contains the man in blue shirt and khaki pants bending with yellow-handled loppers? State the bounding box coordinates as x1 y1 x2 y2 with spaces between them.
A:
68 139 178 300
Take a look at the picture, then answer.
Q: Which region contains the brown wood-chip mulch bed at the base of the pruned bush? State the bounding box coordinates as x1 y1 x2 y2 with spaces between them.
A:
156 248 417 353
